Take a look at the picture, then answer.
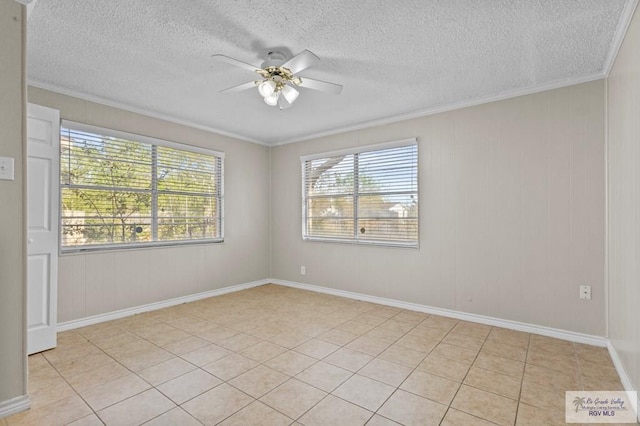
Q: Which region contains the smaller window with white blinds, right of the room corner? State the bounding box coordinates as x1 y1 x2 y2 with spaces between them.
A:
301 139 418 247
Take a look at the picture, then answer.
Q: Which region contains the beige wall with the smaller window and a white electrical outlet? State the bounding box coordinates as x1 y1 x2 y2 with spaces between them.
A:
271 80 606 336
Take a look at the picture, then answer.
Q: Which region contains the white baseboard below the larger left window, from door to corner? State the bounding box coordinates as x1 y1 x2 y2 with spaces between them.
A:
56 280 271 333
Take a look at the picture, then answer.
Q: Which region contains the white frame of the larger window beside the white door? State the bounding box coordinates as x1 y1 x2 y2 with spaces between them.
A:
58 119 225 255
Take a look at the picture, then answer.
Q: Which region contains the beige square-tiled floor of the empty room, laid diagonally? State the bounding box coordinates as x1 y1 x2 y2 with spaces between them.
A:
0 285 622 426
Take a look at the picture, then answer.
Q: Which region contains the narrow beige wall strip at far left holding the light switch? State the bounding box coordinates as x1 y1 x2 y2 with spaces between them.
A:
0 0 26 406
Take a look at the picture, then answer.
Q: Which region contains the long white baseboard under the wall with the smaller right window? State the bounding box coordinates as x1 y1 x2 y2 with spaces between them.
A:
269 278 609 347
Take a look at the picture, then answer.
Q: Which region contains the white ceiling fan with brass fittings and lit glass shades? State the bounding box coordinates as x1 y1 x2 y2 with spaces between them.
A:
213 50 342 110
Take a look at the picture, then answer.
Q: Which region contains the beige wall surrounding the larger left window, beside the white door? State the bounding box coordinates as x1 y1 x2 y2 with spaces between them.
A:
29 87 270 322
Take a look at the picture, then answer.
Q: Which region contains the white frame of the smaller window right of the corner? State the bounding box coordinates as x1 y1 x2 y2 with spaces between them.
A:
300 138 420 249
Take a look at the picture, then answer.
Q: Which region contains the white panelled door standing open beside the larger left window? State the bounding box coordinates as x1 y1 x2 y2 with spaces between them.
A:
27 104 60 354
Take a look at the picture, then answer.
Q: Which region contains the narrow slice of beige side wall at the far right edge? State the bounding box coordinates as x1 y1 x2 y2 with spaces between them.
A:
607 4 640 396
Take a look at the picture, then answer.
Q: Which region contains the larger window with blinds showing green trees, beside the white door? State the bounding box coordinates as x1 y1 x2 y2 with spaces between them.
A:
60 121 224 252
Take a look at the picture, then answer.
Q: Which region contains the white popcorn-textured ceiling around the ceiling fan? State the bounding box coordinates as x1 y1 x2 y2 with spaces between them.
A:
28 0 636 145
